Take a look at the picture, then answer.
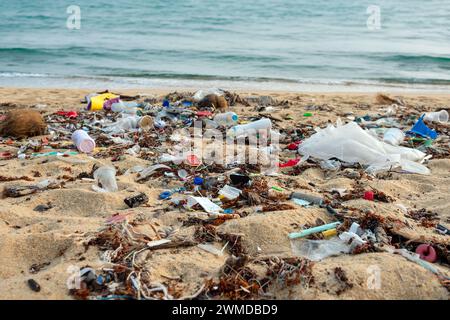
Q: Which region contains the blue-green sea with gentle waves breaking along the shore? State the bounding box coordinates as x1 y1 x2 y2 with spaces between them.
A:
0 0 450 92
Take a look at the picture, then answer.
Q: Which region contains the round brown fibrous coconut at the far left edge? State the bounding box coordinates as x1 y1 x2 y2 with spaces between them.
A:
0 109 47 138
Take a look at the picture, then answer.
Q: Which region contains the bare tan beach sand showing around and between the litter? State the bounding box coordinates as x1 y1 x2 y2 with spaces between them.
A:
0 88 450 300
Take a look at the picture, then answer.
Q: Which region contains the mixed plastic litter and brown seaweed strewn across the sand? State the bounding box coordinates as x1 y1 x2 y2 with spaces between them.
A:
0 89 450 300
